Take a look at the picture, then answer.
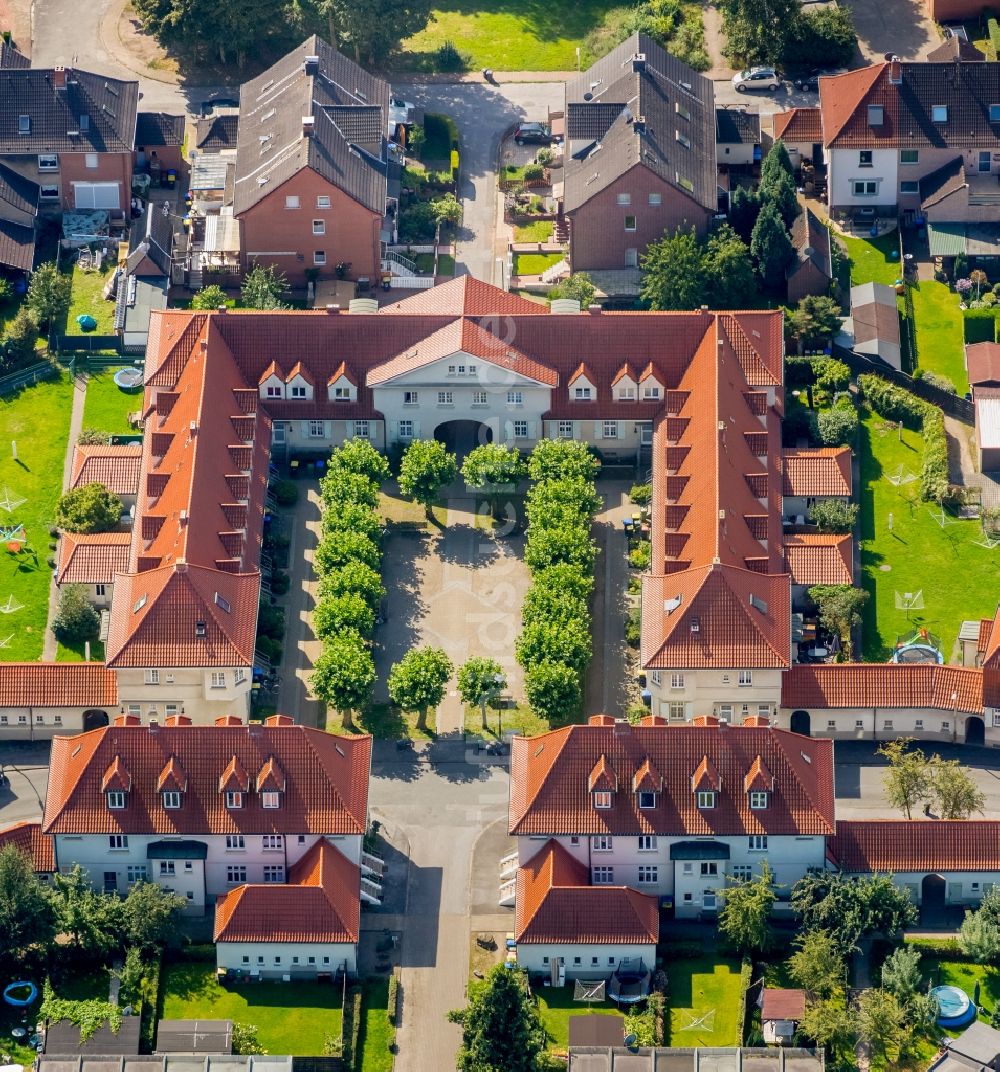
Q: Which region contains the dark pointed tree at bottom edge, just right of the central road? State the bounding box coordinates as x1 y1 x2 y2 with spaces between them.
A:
448 964 546 1072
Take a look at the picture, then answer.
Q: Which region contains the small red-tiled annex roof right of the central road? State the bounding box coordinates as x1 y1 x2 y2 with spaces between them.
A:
514 840 659 946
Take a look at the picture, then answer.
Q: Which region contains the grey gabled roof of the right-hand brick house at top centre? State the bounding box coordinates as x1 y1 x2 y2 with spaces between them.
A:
565 33 717 212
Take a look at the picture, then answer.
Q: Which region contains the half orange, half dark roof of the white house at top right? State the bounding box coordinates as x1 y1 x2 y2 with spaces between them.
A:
820 60 1000 149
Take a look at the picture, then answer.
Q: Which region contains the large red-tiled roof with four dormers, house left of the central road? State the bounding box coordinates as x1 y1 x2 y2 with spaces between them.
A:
43 726 372 835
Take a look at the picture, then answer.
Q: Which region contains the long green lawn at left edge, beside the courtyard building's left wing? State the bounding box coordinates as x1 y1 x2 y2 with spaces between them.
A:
0 375 73 661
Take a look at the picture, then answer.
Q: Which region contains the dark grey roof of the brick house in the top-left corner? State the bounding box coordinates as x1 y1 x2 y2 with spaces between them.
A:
0 69 139 155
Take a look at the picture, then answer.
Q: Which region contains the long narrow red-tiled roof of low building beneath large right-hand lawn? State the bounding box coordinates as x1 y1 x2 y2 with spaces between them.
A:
781 662 983 714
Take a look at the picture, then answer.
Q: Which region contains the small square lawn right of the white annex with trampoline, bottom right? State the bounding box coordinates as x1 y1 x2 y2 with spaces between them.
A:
665 956 741 1046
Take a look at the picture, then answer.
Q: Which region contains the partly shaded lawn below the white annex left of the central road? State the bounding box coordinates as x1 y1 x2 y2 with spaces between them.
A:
157 959 343 1056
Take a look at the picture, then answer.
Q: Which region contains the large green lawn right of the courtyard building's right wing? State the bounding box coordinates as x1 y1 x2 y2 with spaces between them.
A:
860 411 1000 661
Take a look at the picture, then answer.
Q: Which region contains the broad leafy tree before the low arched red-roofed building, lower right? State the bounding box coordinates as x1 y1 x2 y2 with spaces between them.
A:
791 872 916 956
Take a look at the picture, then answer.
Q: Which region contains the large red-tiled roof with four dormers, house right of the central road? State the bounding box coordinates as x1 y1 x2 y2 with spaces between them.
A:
509 723 834 836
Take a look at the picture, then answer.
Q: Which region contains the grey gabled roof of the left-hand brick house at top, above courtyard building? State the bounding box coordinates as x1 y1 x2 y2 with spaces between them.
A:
234 36 389 215
